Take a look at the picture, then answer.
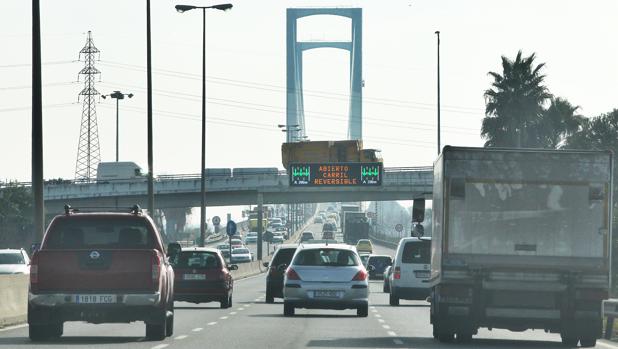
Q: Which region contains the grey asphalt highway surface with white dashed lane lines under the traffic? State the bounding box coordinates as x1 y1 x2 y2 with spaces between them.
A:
0 224 618 349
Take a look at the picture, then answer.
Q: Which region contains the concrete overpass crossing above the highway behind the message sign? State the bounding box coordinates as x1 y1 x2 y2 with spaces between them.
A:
44 167 433 213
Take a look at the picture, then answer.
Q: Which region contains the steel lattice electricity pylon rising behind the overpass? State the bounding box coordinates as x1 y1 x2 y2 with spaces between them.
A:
75 31 101 181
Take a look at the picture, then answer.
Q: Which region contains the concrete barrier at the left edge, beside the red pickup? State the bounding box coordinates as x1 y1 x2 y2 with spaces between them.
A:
0 274 29 327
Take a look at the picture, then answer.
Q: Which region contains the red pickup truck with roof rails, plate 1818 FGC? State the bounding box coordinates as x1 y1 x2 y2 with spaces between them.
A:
28 206 174 341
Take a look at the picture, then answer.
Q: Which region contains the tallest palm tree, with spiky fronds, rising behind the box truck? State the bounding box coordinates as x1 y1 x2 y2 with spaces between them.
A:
481 50 552 147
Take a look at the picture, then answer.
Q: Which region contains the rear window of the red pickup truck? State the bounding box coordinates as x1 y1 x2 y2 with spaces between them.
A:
46 217 155 249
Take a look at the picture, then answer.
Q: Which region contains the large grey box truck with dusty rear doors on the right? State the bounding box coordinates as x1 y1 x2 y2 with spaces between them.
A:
428 146 613 347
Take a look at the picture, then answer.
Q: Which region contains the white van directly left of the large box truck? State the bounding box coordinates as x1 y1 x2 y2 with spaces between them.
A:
389 237 431 305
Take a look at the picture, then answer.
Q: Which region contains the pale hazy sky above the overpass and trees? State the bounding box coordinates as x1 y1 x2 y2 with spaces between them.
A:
0 0 618 181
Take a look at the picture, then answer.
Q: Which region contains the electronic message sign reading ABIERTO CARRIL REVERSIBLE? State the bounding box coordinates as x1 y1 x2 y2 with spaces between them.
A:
289 162 382 187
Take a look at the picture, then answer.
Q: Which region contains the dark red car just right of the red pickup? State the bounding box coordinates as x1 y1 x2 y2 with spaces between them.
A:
170 247 238 309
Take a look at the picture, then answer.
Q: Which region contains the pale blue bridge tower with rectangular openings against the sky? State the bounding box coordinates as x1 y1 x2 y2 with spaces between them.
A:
286 8 363 142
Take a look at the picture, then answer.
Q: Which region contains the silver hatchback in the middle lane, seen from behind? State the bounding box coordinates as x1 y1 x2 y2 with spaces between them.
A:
283 244 369 317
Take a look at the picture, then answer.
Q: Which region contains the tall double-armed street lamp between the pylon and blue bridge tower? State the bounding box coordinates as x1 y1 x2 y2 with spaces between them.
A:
176 4 232 247
